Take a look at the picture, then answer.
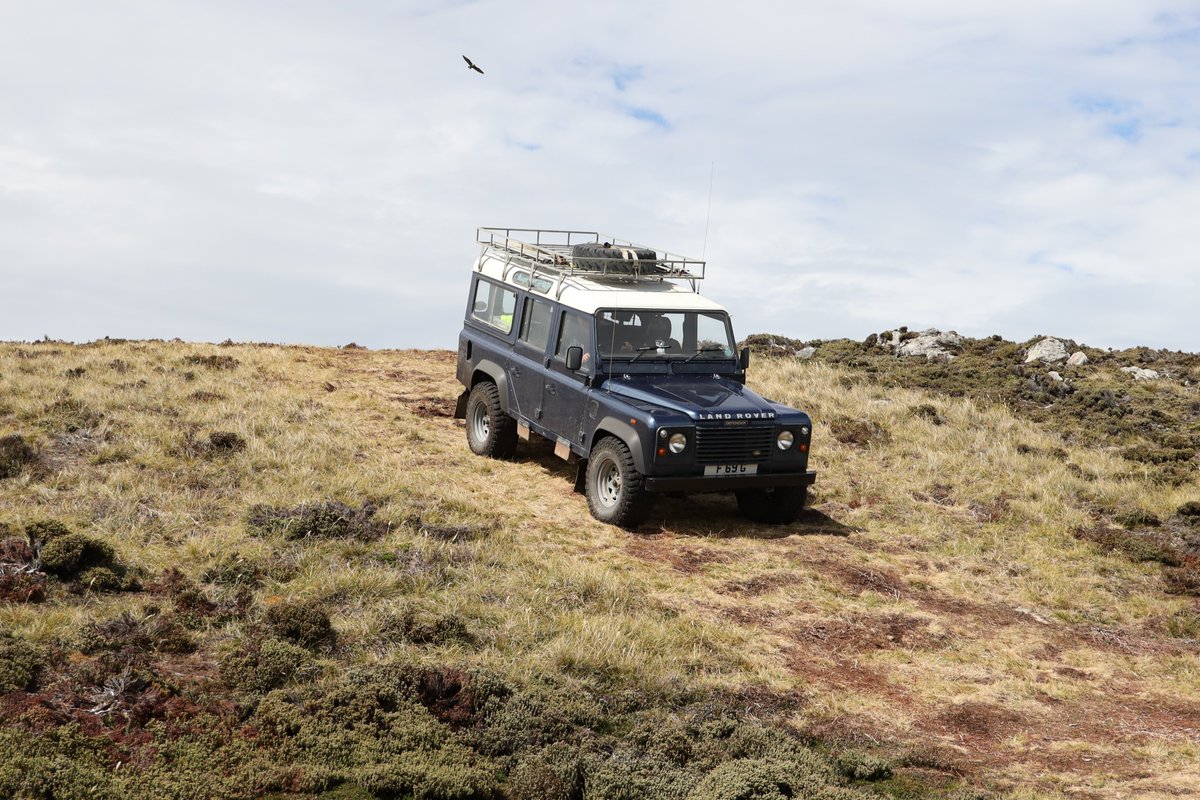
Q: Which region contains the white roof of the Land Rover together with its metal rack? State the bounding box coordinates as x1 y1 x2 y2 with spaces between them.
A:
475 228 725 314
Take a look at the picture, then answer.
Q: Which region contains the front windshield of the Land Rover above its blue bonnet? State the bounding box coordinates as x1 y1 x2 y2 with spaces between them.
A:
596 308 734 361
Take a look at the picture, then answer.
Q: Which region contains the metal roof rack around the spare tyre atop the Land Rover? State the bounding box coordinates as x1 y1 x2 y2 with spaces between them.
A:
475 228 704 291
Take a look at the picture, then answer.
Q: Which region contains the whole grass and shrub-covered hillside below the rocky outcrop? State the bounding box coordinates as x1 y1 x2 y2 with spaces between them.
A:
0 342 1200 800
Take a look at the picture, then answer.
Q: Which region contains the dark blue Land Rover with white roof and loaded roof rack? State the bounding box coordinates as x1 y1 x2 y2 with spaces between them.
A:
455 228 816 528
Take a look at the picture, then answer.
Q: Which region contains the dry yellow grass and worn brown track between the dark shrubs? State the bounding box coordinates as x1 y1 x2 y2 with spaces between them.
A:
0 343 1200 798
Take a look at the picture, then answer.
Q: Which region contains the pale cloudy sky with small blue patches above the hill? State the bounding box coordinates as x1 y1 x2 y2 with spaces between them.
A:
0 0 1200 351
